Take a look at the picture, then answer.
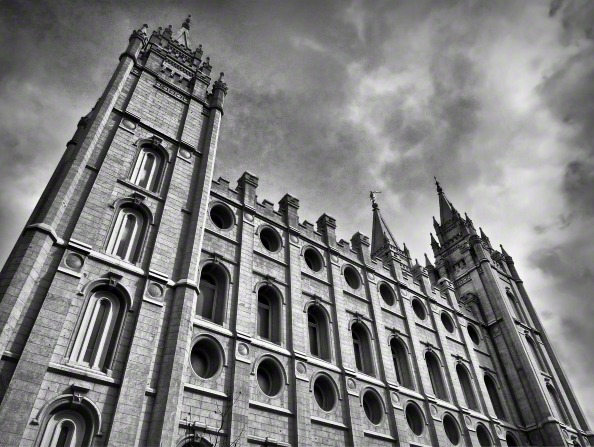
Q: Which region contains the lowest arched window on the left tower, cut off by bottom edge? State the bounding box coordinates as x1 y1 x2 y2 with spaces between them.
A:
38 409 91 447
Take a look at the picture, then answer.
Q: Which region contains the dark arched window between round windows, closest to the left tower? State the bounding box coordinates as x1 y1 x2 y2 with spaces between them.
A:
196 263 229 324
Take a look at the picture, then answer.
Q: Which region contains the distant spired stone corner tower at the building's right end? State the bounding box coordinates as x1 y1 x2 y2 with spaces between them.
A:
431 179 594 445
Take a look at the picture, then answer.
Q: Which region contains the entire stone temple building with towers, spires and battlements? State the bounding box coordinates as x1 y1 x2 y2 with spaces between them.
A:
0 18 594 447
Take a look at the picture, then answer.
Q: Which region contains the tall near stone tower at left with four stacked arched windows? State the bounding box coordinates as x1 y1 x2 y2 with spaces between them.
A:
0 17 227 447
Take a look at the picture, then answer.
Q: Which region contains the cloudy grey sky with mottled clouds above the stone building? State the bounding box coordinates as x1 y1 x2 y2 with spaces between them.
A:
0 0 594 428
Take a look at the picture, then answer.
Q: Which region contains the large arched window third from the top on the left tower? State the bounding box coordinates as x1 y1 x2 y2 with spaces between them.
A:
70 290 126 370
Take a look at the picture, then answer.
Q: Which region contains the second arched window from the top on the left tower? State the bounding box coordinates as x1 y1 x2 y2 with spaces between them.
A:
107 206 146 262
